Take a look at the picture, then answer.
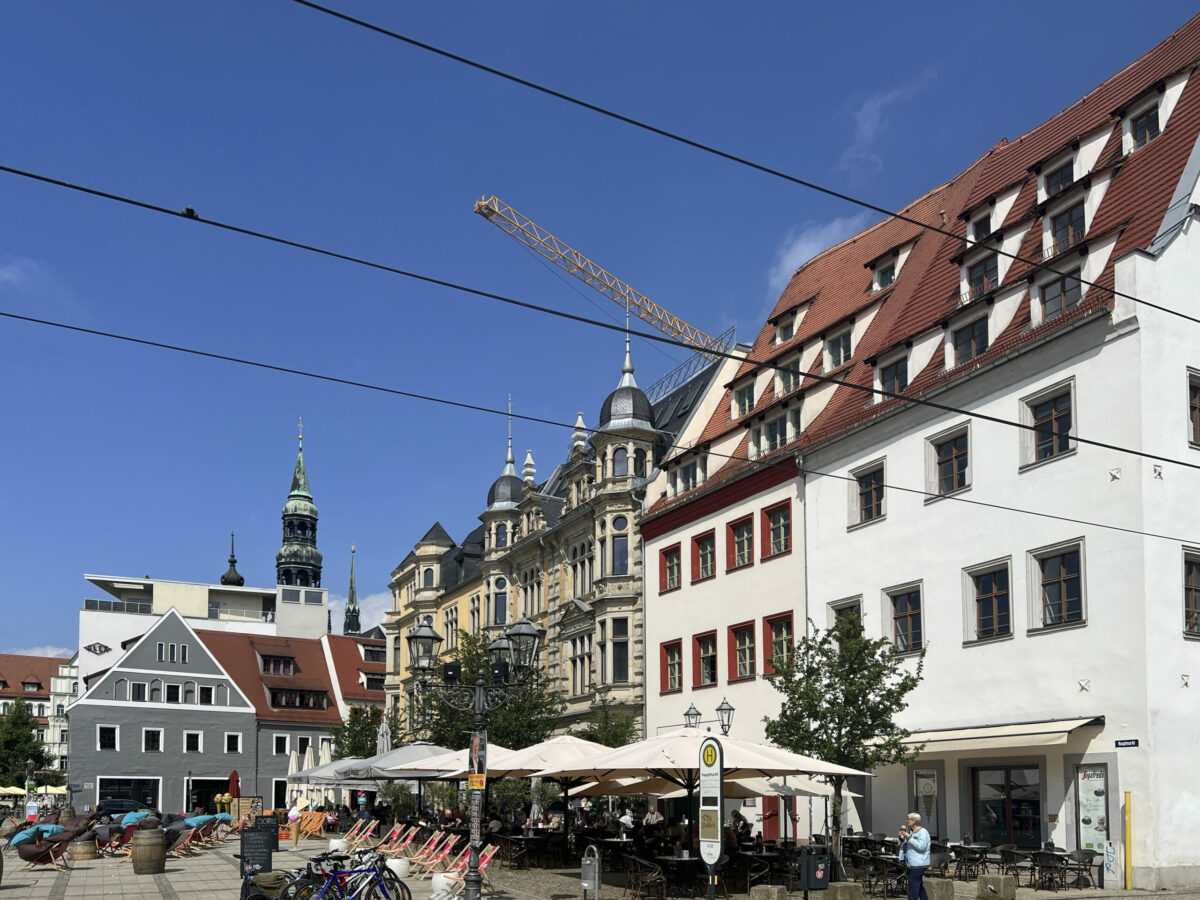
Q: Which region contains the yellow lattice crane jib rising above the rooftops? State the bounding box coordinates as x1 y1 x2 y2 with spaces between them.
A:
475 196 730 360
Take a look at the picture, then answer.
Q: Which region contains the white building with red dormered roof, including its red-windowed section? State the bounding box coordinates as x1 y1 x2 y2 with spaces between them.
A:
641 17 1200 888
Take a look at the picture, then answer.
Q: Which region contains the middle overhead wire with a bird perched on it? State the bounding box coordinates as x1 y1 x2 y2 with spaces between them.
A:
0 163 1200 480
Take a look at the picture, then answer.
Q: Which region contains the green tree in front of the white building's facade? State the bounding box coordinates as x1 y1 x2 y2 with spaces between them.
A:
763 616 925 871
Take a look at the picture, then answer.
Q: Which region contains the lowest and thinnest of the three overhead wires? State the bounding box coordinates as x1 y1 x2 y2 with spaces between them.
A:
0 310 1200 546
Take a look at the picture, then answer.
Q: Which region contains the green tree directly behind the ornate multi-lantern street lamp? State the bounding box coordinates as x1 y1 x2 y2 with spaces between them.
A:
413 630 565 750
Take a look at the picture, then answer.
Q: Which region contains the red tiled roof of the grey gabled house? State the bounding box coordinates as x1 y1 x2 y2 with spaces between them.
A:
196 631 341 725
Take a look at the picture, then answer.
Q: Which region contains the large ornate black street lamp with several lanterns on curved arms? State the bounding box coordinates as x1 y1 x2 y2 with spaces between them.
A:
406 616 545 900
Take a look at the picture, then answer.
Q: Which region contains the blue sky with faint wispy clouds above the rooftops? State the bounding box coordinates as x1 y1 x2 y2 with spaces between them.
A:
0 0 1194 652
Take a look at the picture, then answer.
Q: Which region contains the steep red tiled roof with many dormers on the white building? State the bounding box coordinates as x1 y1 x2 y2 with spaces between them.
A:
644 16 1200 518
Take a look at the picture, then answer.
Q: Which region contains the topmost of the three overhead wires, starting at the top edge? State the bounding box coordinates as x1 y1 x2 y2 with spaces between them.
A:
283 0 1200 325
